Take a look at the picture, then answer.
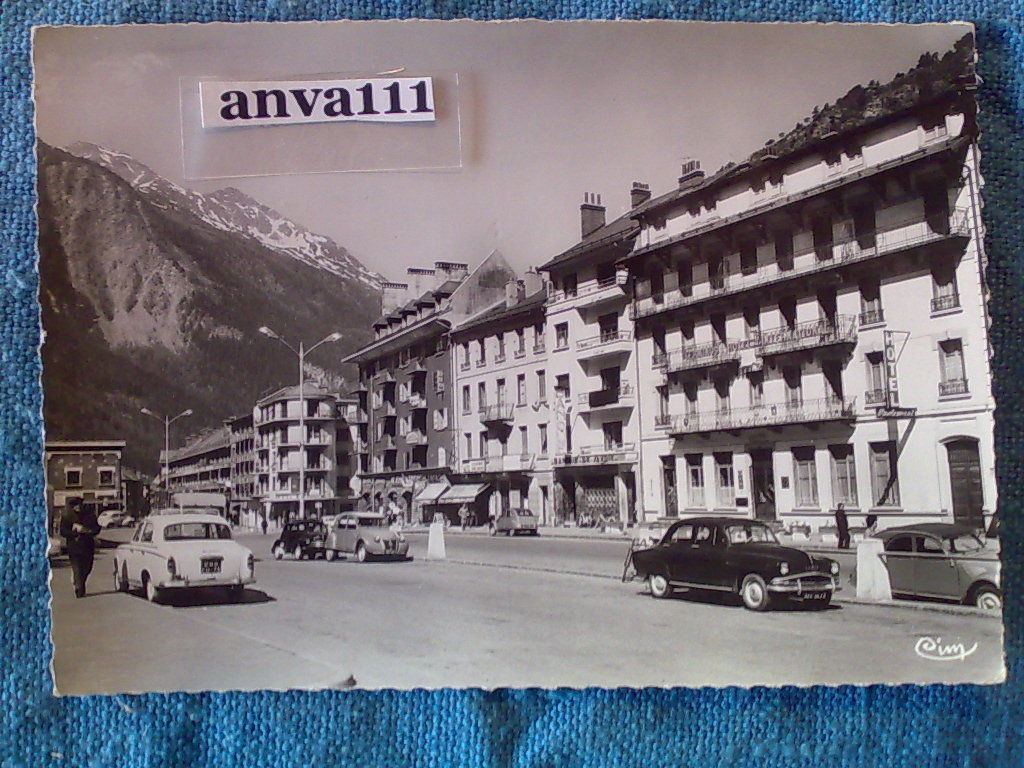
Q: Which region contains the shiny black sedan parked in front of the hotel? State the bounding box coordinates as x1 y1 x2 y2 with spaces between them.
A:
632 517 840 610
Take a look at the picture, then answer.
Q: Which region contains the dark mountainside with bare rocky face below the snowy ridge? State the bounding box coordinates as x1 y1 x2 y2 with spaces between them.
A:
38 143 380 471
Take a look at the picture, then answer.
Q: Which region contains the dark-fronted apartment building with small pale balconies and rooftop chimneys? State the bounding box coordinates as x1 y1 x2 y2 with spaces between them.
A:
343 251 515 521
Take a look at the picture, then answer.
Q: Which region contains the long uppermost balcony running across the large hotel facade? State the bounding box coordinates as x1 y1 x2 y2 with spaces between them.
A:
631 208 971 319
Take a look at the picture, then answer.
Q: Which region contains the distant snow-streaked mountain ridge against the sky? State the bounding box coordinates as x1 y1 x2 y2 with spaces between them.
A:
67 141 382 290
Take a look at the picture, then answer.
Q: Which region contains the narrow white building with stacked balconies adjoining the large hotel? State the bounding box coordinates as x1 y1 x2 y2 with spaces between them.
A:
540 188 650 524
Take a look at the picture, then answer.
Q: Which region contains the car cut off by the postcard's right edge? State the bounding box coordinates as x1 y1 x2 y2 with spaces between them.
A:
878 522 1002 610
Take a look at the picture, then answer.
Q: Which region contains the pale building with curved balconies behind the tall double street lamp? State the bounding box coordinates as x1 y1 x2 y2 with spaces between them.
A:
253 382 348 520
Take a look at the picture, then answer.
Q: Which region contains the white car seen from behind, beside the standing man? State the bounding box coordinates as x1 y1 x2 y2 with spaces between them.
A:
114 514 256 602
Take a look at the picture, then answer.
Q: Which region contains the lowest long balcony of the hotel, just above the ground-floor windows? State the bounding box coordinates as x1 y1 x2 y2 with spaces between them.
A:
658 397 855 436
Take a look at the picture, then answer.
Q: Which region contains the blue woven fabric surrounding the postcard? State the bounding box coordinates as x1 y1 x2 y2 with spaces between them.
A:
0 0 1024 768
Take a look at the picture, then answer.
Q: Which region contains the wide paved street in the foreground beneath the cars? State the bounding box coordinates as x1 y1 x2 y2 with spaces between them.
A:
52 534 1002 694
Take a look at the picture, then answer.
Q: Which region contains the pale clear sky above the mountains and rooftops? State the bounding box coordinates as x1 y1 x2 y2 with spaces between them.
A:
35 22 970 280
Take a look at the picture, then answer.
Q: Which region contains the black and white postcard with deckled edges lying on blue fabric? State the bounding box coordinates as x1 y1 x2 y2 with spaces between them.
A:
33 20 1006 695
